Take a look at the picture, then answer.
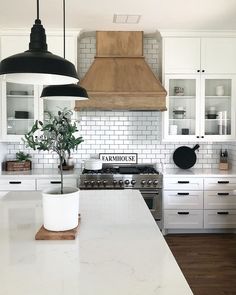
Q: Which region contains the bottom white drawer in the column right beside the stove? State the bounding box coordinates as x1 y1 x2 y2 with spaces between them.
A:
164 210 203 229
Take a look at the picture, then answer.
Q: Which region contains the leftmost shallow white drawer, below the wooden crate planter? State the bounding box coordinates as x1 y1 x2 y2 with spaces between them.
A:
0 178 36 191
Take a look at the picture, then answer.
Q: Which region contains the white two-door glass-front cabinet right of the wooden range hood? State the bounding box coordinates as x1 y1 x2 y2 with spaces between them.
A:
163 75 236 141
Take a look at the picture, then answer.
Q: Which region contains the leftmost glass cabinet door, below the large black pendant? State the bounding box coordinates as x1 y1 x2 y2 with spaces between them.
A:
3 82 35 137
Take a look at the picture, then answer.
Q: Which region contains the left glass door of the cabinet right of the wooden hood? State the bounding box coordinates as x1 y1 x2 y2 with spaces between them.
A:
166 77 199 140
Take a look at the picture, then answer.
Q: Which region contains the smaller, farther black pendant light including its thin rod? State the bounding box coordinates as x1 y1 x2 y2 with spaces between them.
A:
41 0 88 101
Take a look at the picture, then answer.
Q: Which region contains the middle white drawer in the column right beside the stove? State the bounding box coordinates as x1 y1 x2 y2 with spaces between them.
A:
164 190 203 209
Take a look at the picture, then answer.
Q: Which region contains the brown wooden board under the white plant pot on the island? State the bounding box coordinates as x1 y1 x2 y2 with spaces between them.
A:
35 215 80 240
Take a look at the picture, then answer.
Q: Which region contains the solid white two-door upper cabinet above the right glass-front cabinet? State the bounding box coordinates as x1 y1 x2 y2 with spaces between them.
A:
163 37 236 74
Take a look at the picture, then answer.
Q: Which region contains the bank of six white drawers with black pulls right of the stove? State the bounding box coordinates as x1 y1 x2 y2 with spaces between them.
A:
163 175 236 230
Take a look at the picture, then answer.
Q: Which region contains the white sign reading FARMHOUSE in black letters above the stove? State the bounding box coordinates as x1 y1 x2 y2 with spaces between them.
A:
99 153 138 164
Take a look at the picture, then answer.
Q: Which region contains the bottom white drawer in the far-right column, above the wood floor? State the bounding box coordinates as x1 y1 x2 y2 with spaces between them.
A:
204 210 236 228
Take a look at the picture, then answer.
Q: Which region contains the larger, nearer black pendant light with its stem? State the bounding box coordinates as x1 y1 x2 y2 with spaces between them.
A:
0 0 79 85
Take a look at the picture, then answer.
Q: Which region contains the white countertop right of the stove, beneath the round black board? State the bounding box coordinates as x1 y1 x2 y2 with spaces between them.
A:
162 168 236 177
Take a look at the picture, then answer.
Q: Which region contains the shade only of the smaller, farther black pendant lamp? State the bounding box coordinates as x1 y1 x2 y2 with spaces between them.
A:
41 84 88 100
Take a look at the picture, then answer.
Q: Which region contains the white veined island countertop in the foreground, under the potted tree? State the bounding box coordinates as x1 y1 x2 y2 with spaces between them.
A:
0 190 193 295
